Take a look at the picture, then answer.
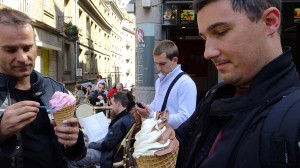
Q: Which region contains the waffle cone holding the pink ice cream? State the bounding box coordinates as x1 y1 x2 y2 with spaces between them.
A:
53 103 76 126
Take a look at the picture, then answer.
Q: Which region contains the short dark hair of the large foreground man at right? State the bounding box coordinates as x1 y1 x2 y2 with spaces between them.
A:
193 0 281 22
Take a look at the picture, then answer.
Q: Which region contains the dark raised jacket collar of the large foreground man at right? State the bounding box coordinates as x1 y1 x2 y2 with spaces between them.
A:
210 47 299 115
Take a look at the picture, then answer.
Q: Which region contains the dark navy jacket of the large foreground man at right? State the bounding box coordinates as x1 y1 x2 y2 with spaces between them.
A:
176 48 300 168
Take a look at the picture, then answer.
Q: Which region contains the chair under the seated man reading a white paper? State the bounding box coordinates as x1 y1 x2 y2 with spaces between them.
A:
113 123 135 168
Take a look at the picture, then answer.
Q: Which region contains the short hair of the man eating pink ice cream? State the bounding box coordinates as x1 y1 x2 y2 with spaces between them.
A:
0 8 33 28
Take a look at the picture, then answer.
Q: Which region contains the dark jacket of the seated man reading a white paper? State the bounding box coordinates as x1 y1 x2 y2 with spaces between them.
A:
89 110 135 168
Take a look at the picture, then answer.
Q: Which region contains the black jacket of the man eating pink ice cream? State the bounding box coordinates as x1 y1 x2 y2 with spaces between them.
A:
0 71 86 168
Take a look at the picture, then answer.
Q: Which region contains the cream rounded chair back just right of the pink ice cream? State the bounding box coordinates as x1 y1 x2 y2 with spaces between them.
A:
75 103 95 128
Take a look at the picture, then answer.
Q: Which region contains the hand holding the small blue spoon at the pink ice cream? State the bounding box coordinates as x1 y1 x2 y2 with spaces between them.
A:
0 101 40 140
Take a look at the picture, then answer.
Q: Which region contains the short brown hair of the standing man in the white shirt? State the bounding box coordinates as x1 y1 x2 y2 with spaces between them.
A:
153 40 179 60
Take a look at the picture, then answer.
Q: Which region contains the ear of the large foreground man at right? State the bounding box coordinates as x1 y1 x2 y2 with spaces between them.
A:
262 7 281 35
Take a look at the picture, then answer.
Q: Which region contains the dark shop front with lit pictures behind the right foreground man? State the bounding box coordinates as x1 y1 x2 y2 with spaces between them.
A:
161 0 300 95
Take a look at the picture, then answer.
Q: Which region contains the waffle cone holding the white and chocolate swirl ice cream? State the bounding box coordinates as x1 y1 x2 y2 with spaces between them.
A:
136 147 178 168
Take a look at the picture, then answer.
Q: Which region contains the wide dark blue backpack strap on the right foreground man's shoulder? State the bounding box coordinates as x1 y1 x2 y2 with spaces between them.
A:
261 89 300 168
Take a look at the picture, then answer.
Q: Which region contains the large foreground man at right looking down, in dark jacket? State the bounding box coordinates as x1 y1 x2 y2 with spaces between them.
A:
175 0 300 168
